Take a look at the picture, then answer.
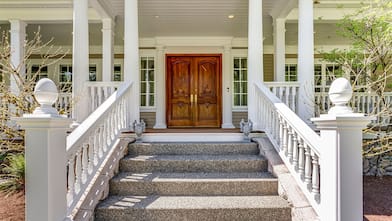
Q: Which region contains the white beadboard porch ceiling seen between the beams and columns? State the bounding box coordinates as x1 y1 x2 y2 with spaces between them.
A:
0 0 366 45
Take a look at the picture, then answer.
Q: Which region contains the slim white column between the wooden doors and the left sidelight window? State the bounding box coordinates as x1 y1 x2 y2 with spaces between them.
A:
154 45 167 129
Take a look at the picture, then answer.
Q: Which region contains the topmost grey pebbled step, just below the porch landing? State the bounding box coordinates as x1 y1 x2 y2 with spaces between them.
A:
129 142 259 155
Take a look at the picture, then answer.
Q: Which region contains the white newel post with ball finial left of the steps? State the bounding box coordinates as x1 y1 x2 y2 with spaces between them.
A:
13 78 71 221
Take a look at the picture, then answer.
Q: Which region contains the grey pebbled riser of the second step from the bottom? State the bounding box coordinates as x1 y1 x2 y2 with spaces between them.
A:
110 180 278 196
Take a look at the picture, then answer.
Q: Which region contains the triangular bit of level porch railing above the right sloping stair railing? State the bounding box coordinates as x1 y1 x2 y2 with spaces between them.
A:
264 82 299 112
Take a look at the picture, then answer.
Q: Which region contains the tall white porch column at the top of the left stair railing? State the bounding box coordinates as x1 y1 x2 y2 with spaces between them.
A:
124 0 140 122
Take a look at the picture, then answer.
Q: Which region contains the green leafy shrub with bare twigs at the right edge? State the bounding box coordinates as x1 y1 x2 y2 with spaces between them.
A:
323 0 392 164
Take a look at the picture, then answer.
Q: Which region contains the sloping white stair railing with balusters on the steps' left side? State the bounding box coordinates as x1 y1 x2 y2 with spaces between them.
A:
67 81 132 217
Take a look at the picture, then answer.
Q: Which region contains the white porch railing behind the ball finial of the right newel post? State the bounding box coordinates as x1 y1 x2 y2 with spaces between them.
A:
315 92 392 124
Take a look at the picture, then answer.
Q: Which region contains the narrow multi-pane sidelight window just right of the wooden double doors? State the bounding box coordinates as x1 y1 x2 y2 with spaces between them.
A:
233 58 248 107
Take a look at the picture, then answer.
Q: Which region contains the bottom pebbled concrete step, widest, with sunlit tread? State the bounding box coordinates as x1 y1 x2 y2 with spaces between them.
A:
95 196 291 221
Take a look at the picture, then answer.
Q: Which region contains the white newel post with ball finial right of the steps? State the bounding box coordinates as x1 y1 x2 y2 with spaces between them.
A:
312 78 371 221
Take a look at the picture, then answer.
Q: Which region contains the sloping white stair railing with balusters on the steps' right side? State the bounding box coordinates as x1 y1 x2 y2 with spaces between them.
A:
255 84 321 213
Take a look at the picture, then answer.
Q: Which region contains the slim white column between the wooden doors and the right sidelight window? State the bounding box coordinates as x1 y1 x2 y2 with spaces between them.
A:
222 45 235 128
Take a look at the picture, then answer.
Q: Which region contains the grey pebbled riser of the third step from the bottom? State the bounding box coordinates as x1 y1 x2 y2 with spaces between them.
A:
120 159 267 173
